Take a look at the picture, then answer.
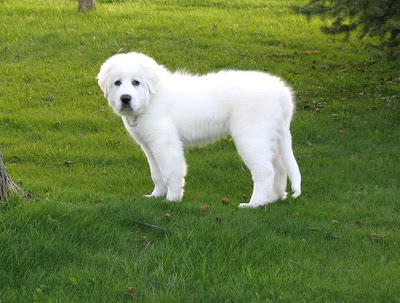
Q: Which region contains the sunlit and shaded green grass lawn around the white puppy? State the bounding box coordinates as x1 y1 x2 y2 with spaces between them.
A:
0 0 400 303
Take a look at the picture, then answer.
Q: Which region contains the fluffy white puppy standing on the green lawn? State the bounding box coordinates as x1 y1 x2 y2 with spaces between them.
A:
97 53 301 207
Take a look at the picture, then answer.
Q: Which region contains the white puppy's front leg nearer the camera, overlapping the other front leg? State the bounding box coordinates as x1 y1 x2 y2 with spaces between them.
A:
151 137 186 201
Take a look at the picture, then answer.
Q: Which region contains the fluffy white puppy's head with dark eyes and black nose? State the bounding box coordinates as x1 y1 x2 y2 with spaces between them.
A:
97 53 167 116
